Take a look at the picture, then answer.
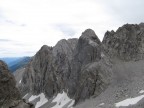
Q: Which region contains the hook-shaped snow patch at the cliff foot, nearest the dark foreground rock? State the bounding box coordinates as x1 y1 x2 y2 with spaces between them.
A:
29 93 48 108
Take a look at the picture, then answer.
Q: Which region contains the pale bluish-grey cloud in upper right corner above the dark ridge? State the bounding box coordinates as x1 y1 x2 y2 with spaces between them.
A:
98 0 144 23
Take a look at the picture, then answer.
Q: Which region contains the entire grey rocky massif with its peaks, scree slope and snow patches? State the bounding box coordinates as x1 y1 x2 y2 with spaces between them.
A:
15 23 144 108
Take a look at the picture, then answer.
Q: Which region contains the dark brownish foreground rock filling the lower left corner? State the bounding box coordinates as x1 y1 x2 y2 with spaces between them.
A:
0 61 32 108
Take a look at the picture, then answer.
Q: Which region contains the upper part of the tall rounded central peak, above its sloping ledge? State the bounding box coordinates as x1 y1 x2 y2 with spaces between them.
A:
74 29 101 64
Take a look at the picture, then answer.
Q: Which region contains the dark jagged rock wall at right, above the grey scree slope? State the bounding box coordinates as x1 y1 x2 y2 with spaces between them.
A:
102 23 144 61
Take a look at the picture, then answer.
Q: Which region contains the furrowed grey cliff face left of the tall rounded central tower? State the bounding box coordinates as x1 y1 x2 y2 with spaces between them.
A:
20 39 77 97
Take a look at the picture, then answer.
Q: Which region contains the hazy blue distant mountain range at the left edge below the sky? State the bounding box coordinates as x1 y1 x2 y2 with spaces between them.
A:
0 57 31 72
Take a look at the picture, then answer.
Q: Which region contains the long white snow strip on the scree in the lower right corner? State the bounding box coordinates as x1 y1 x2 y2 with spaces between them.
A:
115 95 144 107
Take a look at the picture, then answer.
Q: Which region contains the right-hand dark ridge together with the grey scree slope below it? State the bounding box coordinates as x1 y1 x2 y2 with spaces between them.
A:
76 23 144 108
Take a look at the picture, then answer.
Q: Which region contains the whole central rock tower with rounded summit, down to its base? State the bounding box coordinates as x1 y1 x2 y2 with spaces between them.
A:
68 29 109 102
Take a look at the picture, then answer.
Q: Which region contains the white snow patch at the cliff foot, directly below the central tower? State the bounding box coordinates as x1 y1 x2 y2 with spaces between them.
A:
52 91 75 108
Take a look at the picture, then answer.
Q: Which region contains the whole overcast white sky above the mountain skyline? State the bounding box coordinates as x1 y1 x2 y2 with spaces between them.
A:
0 0 144 58
